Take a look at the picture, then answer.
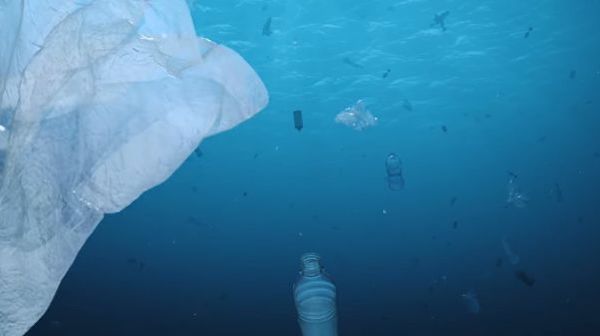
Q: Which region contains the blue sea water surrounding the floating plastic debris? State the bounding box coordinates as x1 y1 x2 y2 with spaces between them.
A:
28 0 600 336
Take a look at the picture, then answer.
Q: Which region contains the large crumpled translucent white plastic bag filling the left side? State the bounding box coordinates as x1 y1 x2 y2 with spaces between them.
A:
0 0 268 336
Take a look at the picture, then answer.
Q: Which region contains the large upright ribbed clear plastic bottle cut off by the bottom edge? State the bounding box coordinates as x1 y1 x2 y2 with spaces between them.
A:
294 252 337 336
